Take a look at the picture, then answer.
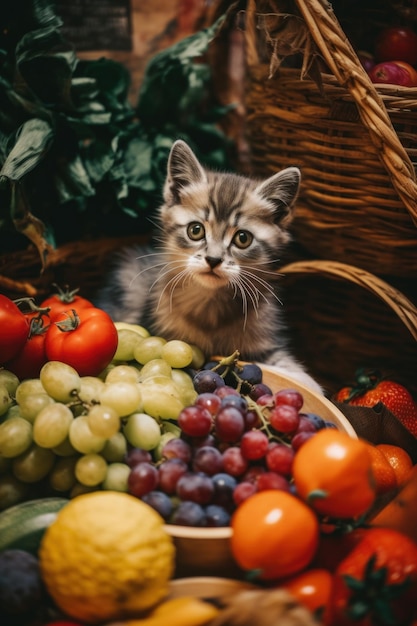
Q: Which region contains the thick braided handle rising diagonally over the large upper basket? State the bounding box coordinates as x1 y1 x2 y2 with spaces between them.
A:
247 0 417 225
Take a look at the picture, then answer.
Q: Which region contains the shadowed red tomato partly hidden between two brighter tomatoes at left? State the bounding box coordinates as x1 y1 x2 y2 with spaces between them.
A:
6 313 50 380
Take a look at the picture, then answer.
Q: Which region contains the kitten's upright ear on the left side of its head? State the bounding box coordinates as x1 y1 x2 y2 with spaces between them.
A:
164 139 207 201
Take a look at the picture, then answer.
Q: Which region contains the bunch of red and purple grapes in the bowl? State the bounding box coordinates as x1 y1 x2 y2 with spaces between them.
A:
126 363 335 527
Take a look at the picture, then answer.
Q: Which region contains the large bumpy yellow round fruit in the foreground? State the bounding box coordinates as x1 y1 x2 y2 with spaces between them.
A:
39 491 175 624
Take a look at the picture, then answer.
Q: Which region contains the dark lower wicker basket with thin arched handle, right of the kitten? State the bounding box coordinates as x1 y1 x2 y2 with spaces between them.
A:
280 260 417 398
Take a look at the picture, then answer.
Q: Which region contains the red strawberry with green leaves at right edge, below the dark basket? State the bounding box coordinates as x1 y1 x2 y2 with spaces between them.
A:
334 370 417 437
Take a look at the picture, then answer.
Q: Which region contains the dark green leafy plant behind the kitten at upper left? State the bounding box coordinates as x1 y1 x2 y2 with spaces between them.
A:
0 0 234 264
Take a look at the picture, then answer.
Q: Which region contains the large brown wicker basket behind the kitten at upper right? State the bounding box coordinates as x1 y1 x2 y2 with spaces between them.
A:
246 0 417 278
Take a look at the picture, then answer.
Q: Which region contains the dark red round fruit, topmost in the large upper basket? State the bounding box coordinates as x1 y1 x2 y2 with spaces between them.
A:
375 26 417 65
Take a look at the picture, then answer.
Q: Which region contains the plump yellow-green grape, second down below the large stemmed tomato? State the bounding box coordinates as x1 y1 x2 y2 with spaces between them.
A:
33 402 74 448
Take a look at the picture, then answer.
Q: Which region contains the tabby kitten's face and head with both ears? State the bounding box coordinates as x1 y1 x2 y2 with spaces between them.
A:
160 142 300 291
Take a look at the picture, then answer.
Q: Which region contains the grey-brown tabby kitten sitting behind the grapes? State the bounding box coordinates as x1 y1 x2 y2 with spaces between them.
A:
96 140 321 392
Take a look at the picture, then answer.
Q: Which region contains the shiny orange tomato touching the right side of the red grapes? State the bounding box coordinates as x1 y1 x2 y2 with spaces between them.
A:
292 428 376 519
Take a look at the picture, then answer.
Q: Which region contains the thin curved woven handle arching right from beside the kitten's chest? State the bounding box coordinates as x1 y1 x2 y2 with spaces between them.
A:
279 260 417 341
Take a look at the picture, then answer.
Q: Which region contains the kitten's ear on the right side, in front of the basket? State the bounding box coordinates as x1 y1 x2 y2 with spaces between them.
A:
256 167 301 224
